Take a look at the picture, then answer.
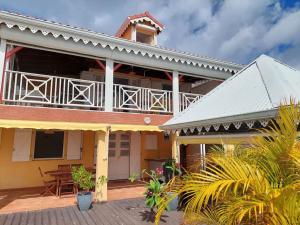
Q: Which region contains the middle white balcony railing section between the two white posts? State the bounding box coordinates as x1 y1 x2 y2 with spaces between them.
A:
113 84 172 113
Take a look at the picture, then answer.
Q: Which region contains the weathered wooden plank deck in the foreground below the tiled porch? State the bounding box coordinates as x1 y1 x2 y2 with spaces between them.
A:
0 198 182 225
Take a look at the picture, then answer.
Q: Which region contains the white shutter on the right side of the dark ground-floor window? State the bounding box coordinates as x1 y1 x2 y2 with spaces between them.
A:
67 131 82 160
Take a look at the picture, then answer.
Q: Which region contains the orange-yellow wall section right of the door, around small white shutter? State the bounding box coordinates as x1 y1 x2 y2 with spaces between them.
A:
141 132 172 170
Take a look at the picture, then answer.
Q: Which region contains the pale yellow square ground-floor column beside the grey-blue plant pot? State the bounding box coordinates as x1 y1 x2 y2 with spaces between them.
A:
95 130 109 201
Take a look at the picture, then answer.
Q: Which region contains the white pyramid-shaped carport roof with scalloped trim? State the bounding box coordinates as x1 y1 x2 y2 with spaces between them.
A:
161 55 300 131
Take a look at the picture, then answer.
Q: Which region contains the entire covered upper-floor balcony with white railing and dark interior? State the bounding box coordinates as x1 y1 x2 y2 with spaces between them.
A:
1 45 222 115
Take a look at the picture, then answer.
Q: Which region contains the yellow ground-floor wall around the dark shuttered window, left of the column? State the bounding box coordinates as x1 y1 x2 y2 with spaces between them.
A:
0 129 95 189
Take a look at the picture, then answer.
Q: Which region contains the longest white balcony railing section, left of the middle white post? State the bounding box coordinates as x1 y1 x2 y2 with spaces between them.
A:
3 71 104 109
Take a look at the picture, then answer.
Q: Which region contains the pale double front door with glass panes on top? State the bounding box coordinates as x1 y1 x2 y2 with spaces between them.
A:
108 132 130 180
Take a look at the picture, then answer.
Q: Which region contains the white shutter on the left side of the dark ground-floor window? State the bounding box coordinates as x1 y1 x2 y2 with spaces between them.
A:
12 129 32 162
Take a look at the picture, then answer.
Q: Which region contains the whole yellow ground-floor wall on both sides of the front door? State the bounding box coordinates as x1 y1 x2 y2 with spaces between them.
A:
0 129 172 189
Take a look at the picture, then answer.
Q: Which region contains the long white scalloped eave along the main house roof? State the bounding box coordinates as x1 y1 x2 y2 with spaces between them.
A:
0 11 243 72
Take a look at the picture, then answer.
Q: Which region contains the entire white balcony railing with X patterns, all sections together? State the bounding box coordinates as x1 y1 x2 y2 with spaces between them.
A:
2 70 202 114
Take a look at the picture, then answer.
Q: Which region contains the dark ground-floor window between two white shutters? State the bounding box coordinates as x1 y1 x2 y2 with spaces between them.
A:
34 131 64 159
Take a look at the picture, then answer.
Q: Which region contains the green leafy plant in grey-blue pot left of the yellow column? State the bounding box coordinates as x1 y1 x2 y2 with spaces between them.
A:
72 166 95 211
